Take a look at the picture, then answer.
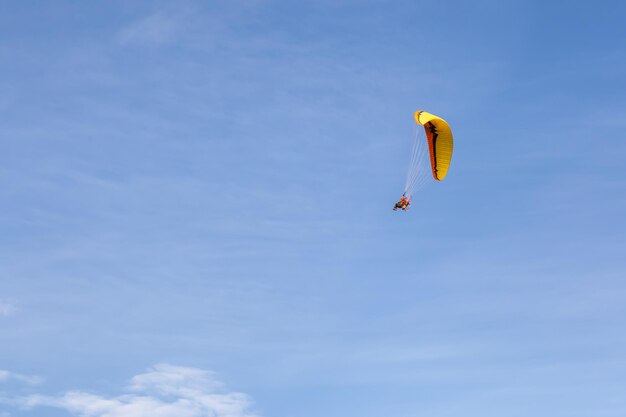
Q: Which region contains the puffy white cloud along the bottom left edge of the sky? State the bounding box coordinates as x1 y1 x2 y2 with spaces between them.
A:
19 364 255 417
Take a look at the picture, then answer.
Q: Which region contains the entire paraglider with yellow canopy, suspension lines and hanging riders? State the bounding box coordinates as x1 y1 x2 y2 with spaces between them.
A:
393 110 454 211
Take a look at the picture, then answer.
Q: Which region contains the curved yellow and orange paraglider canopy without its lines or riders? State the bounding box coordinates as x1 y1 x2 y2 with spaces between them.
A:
415 110 454 181
